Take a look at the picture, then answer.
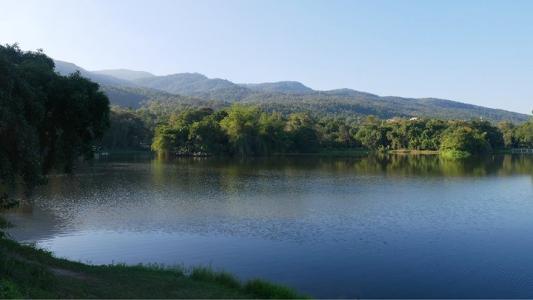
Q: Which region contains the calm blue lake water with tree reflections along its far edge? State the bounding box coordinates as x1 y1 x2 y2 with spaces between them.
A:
3 156 533 298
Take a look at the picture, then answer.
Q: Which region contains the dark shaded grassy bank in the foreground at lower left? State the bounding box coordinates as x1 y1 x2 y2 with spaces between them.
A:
0 218 306 299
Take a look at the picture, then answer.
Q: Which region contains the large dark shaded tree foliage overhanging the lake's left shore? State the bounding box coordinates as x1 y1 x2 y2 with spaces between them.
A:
0 45 109 187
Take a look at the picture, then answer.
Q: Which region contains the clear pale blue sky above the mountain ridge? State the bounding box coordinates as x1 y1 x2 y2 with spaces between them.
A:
0 0 533 113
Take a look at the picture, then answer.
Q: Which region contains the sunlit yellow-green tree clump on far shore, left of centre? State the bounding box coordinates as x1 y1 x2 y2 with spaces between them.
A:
152 104 319 156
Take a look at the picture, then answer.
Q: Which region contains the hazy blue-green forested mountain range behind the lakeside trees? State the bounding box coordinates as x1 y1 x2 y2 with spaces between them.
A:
56 61 529 122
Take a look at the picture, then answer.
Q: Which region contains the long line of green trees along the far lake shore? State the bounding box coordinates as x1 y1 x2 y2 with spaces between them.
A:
104 104 533 156
